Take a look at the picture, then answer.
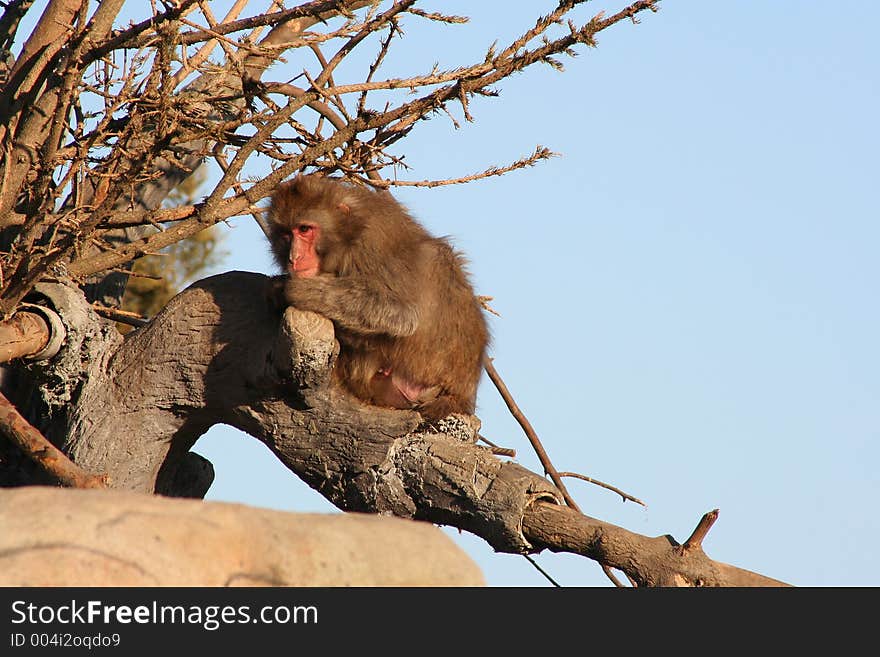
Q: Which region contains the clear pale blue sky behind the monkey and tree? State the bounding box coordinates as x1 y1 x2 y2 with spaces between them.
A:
17 0 880 586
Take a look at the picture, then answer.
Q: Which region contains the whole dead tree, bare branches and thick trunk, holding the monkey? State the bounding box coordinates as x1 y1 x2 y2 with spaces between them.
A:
0 0 778 585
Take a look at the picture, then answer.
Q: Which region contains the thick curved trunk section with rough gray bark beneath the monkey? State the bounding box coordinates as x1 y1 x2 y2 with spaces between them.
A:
18 272 559 552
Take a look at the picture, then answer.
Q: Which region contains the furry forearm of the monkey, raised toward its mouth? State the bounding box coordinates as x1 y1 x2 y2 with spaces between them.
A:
284 276 420 337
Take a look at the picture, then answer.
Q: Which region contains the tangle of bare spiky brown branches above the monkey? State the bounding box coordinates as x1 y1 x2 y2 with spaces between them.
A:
0 0 655 314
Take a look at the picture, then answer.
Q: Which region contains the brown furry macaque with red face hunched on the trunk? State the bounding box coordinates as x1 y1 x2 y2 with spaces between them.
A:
269 175 489 419
